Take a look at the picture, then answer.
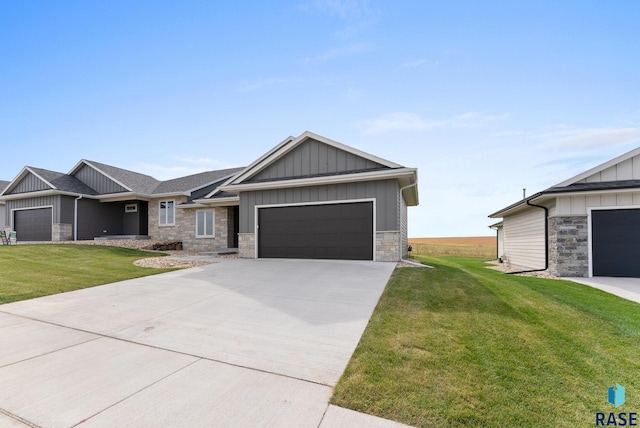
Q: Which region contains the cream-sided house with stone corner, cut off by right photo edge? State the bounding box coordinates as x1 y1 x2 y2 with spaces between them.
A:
489 147 640 277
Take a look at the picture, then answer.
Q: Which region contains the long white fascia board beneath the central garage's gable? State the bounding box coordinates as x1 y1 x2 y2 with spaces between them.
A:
220 168 416 193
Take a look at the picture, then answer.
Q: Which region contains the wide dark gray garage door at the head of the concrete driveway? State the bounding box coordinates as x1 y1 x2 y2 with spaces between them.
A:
258 202 373 260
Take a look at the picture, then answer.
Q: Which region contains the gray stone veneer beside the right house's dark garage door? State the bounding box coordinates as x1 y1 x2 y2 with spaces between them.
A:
549 216 589 277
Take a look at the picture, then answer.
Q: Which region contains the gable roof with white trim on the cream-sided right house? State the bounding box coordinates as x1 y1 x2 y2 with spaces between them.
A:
489 147 640 218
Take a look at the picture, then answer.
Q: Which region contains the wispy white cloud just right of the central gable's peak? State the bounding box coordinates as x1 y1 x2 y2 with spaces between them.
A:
356 112 508 135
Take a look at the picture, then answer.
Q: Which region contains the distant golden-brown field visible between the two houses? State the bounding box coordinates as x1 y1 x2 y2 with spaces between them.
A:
409 236 496 259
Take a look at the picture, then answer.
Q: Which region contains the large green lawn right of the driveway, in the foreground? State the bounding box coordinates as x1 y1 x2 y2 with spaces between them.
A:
331 257 640 427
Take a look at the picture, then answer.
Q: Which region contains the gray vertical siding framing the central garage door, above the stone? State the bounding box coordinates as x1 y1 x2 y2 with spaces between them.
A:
240 180 400 233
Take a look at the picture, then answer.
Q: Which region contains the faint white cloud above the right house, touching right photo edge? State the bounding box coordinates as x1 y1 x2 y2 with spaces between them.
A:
543 128 640 149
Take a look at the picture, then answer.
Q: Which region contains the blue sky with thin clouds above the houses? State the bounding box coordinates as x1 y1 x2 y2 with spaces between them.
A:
0 0 640 237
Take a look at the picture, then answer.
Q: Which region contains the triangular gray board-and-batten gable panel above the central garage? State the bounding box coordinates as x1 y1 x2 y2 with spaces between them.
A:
246 139 384 182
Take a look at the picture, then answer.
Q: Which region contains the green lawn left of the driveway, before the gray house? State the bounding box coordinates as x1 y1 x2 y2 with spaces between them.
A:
0 245 175 304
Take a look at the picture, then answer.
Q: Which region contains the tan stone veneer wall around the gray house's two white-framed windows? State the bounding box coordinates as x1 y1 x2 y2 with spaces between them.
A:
149 197 228 251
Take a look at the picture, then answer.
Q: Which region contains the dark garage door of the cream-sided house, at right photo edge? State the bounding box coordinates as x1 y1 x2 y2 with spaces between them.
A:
591 209 640 277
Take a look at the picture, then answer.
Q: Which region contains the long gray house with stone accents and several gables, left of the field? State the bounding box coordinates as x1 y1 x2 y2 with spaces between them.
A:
0 132 418 261
